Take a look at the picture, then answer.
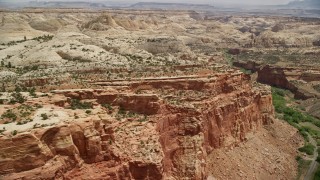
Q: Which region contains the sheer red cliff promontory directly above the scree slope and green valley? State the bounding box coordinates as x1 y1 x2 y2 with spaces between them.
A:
158 74 273 179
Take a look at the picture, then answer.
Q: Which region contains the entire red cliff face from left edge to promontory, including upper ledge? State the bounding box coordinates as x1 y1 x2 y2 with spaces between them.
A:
0 72 274 180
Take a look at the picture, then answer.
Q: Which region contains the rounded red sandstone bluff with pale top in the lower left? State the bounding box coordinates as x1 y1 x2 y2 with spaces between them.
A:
0 122 103 178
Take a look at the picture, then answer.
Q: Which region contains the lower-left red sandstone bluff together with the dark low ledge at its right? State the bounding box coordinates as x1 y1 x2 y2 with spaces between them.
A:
0 120 162 179
